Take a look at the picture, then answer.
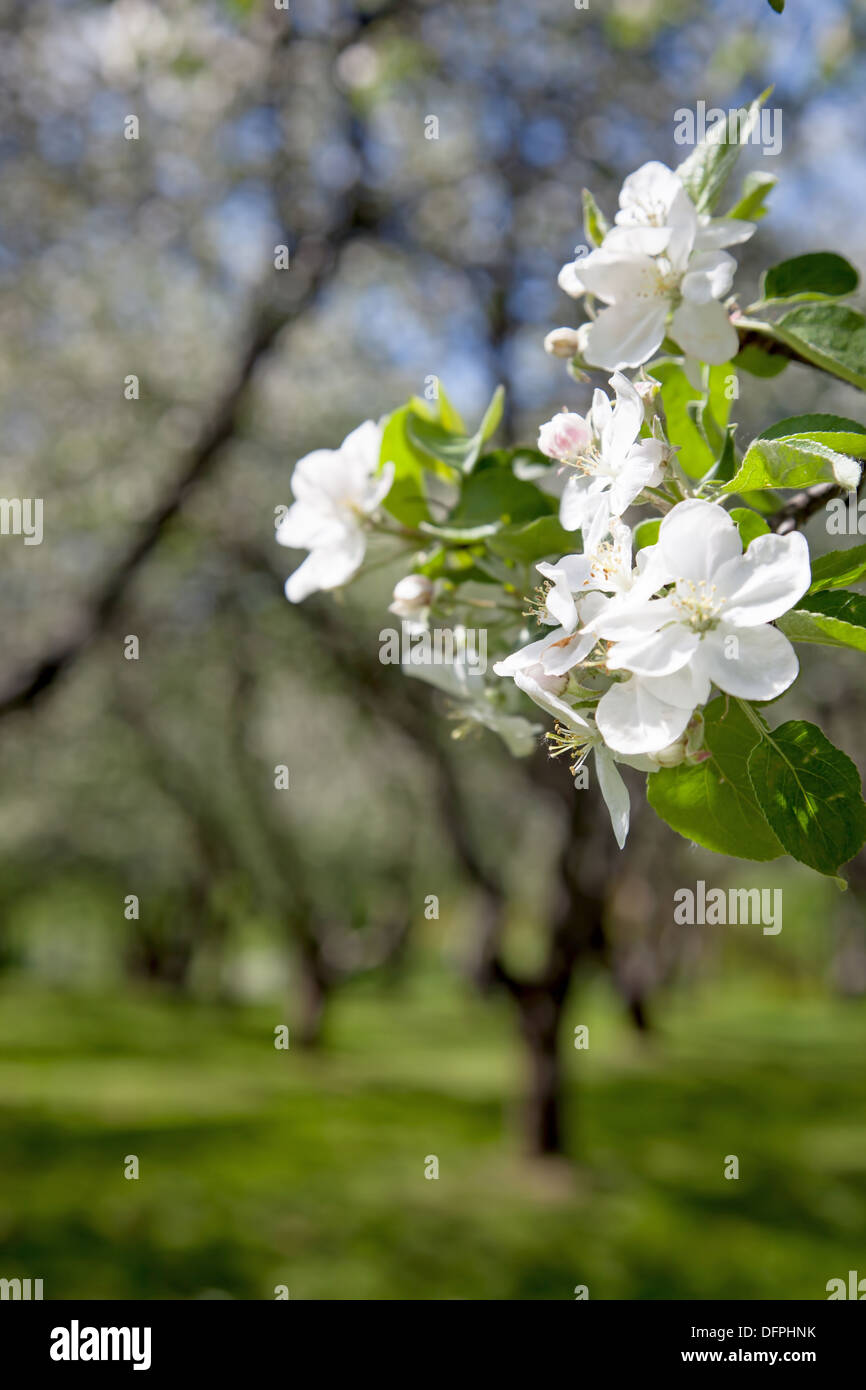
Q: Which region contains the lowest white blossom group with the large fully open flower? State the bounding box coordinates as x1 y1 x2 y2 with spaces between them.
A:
493 498 810 845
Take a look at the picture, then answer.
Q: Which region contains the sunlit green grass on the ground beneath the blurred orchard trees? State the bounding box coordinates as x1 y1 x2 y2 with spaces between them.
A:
0 970 866 1300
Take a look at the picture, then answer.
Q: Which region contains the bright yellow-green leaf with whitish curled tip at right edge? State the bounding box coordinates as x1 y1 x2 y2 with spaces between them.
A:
724 416 866 492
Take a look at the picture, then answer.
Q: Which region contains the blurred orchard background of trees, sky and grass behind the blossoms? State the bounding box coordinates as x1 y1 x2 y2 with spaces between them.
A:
0 0 866 1298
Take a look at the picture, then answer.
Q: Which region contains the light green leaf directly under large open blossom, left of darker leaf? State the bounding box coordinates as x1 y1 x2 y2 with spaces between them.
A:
646 699 783 860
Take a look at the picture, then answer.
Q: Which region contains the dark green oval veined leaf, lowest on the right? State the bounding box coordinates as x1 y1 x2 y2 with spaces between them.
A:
748 712 866 876
